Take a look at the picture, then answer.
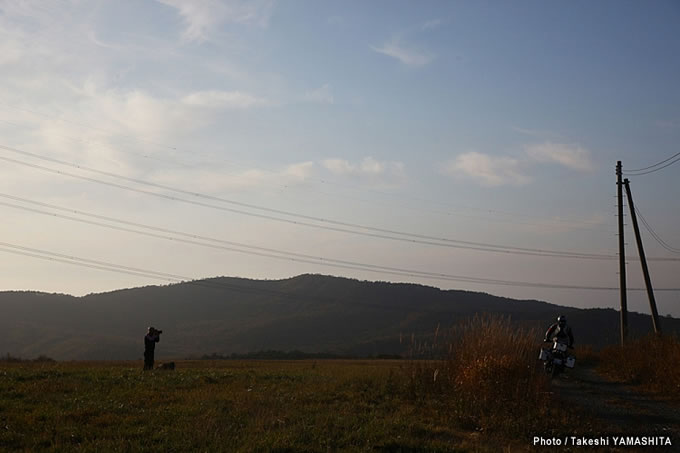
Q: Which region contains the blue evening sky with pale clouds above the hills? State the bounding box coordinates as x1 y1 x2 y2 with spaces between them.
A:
0 0 680 317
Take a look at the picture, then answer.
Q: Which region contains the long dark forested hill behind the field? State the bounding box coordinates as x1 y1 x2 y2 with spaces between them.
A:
0 275 680 360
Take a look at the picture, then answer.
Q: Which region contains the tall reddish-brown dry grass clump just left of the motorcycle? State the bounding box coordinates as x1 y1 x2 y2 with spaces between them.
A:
410 316 589 438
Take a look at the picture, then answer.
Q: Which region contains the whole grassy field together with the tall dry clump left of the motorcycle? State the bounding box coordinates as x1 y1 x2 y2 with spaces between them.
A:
0 319 604 452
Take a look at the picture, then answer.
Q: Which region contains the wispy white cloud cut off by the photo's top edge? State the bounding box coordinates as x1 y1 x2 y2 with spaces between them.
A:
157 0 274 42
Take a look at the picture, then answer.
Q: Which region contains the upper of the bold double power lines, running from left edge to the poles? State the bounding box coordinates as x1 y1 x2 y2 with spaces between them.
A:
0 145 612 259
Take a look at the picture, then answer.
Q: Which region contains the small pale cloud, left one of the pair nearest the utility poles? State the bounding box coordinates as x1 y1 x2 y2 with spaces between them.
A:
442 151 531 187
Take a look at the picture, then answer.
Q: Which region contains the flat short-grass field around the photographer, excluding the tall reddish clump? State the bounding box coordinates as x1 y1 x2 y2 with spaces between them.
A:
0 361 474 452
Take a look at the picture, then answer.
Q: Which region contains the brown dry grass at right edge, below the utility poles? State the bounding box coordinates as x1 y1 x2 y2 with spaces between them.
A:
599 335 680 398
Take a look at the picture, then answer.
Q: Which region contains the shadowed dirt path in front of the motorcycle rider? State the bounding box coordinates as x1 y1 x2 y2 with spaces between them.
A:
553 367 680 442
